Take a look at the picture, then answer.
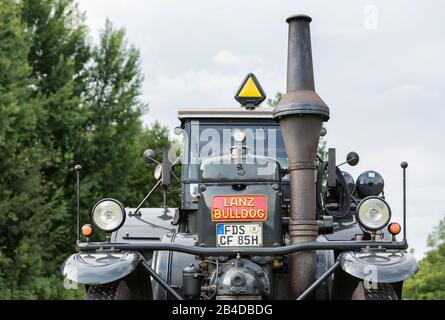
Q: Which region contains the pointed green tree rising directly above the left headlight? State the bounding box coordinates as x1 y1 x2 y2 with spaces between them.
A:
80 21 146 208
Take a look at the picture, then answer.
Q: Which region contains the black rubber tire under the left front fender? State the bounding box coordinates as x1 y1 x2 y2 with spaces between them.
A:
85 280 131 300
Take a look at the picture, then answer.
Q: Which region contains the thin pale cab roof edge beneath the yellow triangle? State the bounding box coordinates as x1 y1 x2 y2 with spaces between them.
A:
178 107 274 122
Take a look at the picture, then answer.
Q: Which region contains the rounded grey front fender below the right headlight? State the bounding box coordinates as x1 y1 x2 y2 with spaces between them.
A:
339 251 419 283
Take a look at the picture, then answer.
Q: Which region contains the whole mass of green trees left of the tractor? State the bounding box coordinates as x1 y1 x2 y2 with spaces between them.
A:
0 0 173 299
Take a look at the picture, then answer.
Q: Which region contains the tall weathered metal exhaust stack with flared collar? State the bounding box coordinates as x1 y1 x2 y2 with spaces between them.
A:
274 15 329 298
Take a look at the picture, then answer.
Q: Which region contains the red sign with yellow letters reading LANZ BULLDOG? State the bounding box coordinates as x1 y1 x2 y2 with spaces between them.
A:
211 194 267 222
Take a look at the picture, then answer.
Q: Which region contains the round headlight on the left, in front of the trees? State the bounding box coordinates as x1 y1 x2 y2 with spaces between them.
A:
92 199 125 232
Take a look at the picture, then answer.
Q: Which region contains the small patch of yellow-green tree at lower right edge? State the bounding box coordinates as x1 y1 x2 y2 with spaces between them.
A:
403 218 445 300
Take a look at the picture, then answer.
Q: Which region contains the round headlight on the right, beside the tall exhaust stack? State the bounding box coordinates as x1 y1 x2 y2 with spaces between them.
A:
357 197 391 231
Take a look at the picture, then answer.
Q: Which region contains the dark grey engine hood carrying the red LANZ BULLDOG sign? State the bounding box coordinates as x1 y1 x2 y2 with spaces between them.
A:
197 156 282 247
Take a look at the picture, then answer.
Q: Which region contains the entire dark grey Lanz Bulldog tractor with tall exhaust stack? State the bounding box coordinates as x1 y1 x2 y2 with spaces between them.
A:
62 15 418 300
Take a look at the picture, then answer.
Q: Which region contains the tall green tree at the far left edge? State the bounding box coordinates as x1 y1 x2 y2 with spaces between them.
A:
0 0 83 298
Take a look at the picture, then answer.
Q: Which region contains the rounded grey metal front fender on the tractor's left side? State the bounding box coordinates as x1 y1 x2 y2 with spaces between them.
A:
61 252 141 285
